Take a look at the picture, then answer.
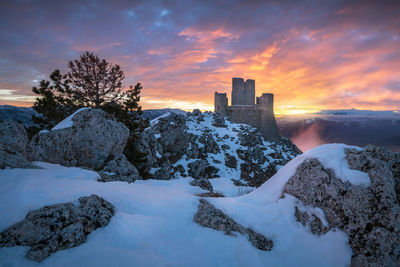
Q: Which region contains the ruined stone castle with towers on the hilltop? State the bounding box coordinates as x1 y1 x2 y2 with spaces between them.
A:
214 78 279 141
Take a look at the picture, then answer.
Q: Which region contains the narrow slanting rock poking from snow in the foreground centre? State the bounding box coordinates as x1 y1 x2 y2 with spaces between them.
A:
194 199 273 251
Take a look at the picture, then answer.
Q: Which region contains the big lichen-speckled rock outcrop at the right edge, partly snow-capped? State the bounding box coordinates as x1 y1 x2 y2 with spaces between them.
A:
283 146 400 266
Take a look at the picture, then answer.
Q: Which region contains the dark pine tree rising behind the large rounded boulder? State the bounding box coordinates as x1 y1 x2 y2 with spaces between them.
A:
28 52 148 172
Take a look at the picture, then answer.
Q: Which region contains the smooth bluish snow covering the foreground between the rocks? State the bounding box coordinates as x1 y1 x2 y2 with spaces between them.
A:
0 145 356 266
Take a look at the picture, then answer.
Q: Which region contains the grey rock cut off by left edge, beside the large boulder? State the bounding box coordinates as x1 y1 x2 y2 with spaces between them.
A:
0 121 33 169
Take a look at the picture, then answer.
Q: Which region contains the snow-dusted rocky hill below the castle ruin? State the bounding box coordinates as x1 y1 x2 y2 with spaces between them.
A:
137 110 301 187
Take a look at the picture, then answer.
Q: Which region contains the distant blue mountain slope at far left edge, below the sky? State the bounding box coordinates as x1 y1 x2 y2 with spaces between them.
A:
0 105 38 127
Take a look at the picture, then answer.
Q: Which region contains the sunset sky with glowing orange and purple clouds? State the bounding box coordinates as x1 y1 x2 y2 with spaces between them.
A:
0 0 400 115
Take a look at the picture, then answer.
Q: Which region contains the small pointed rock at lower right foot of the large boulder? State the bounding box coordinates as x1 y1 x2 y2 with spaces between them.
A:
99 154 140 183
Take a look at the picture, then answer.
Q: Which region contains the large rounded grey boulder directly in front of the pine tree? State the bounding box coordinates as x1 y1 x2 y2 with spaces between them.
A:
30 109 129 170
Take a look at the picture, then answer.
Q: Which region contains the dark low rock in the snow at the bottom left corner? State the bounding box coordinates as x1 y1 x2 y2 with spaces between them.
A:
0 195 115 262
